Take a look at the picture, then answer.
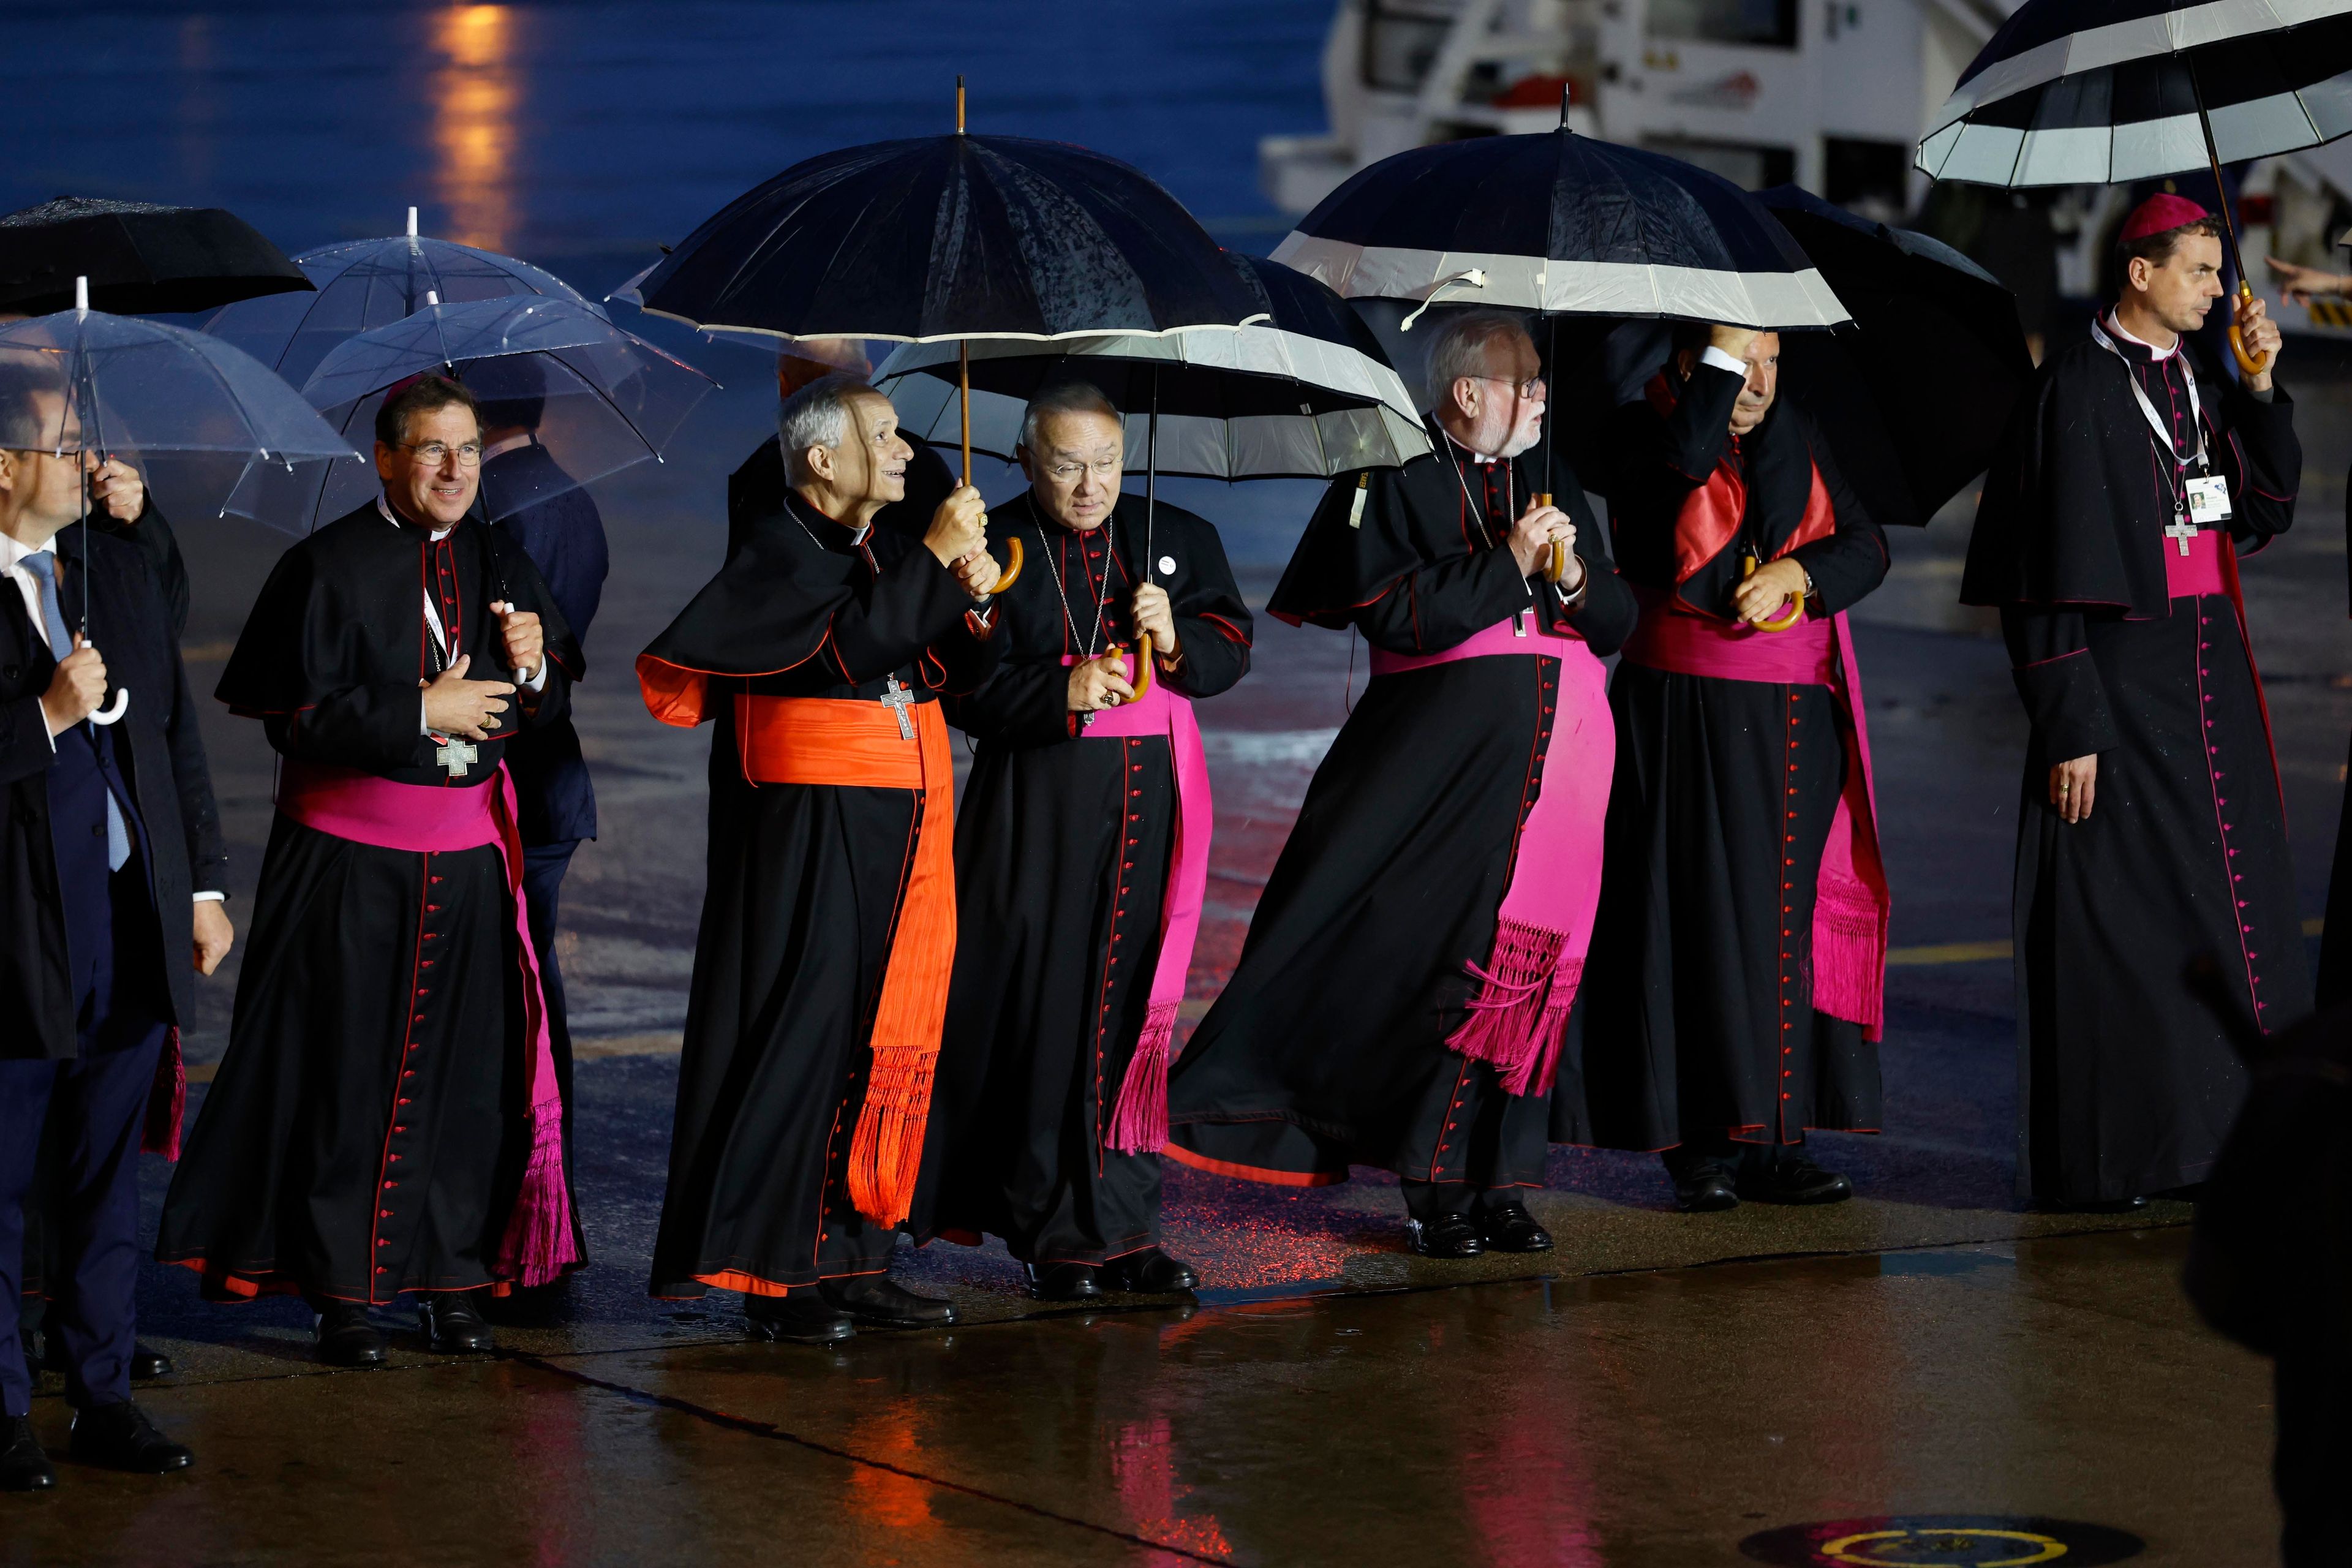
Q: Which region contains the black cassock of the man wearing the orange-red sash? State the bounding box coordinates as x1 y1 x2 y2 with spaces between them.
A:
638 494 997 1298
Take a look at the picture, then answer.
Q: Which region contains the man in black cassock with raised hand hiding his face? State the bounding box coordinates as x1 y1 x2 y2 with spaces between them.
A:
1555 326 1887 1211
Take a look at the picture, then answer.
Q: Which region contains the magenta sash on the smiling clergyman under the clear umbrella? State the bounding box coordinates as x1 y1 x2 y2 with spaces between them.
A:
277 760 579 1286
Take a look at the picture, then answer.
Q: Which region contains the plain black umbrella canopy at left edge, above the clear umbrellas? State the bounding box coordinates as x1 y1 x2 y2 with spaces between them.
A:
0 195 311 315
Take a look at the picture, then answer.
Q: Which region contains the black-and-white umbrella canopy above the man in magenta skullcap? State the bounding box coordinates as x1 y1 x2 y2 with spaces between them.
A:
1919 0 2352 186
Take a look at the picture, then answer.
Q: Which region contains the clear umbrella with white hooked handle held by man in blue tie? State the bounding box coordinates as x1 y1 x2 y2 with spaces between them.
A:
0 280 360 724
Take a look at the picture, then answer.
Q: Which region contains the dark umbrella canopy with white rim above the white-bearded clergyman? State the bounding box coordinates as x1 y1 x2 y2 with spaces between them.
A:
1275 127 1846 329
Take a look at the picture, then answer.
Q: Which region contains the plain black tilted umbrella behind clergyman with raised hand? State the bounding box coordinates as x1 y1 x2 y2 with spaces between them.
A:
1757 186 2035 527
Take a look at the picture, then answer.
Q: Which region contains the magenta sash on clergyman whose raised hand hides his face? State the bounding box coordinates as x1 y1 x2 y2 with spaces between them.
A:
1625 583 1893 1039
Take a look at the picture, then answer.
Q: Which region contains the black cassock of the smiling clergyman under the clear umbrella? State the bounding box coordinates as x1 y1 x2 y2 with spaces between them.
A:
157 505 583 1302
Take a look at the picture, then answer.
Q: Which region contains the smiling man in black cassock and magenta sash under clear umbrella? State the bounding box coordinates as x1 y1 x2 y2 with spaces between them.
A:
157 376 581 1366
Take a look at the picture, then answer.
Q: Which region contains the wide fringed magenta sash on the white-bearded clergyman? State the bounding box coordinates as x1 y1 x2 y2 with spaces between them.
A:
1371 611 1616 1096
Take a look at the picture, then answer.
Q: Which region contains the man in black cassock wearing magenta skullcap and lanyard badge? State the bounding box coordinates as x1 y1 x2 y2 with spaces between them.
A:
1959 195 2312 1208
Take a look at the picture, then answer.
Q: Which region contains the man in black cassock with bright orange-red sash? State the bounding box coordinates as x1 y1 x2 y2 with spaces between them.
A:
638 376 997 1344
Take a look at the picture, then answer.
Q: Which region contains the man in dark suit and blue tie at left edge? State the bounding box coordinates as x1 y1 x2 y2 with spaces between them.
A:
0 364 230 1490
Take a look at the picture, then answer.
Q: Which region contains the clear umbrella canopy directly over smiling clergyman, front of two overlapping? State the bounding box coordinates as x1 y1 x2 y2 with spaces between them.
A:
288 294 715 524
